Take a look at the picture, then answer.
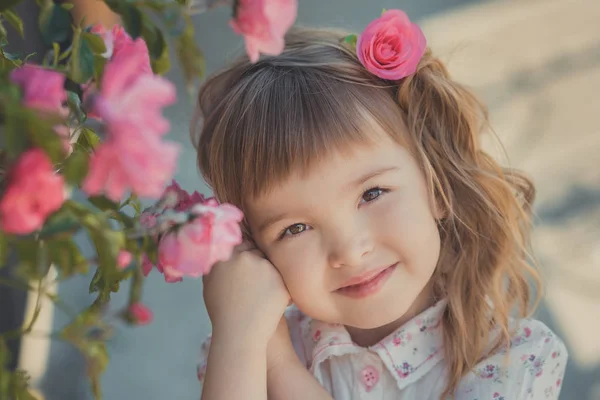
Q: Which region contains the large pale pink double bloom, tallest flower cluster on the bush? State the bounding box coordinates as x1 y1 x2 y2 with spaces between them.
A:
83 41 179 201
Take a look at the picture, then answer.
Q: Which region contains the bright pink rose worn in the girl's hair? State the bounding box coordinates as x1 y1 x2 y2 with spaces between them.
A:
356 10 427 80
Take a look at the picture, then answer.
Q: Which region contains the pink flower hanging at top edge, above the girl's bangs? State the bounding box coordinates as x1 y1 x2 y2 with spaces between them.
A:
229 0 298 63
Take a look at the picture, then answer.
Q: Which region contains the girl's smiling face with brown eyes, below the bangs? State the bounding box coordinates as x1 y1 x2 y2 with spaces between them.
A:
246 130 440 329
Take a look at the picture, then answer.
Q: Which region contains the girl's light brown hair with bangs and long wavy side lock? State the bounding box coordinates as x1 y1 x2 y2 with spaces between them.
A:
192 28 540 398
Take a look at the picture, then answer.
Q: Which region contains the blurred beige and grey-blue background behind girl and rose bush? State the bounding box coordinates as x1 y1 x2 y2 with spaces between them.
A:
0 0 600 400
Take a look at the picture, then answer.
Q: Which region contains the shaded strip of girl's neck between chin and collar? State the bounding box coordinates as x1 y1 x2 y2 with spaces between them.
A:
346 285 435 347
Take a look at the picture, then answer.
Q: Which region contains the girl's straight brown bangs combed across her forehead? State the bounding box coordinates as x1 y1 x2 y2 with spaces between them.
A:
204 63 400 206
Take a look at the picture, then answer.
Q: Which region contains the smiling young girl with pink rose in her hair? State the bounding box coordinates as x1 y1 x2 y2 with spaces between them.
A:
194 10 567 400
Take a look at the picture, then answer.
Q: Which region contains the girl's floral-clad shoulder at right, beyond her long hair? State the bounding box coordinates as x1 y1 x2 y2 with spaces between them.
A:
457 319 568 400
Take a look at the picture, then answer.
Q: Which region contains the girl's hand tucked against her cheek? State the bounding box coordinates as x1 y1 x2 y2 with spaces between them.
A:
204 243 290 346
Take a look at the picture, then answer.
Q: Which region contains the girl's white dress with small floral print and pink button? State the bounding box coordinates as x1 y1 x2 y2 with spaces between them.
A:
197 301 567 400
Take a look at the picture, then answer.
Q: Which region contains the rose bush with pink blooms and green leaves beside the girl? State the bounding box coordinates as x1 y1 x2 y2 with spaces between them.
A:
0 0 297 399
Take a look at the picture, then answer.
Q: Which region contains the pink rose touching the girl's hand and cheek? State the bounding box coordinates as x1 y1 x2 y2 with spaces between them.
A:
157 199 243 278
